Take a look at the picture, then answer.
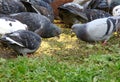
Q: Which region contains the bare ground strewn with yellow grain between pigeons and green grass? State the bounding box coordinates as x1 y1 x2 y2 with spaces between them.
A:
0 21 120 63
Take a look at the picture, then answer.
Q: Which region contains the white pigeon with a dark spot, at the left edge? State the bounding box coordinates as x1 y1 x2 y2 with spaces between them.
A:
0 17 28 35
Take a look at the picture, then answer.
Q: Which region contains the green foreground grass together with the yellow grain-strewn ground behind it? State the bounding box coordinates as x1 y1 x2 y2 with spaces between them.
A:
0 25 120 82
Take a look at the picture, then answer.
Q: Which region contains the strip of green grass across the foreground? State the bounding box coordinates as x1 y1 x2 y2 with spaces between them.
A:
0 54 120 82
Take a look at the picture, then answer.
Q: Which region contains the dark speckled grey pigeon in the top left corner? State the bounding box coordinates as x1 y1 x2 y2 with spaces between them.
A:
0 0 26 14
